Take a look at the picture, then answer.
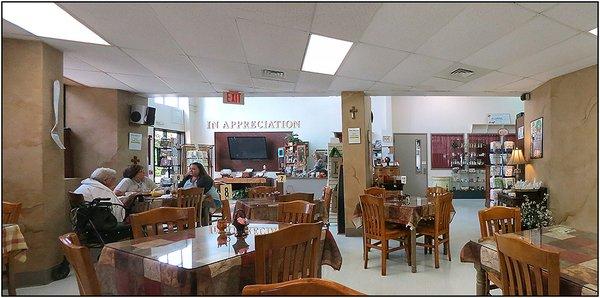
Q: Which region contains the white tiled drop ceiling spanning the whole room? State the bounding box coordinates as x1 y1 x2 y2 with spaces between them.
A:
2 2 598 96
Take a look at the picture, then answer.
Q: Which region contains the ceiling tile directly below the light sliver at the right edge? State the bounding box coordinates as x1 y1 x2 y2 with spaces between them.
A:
500 33 598 77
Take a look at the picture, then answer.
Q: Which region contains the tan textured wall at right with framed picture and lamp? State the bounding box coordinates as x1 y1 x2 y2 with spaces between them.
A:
525 65 598 231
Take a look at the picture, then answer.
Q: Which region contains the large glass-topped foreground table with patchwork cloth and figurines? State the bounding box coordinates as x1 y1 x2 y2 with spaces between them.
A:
96 221 342 296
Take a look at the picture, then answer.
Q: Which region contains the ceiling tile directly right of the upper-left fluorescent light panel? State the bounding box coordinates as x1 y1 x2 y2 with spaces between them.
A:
58 2 181 53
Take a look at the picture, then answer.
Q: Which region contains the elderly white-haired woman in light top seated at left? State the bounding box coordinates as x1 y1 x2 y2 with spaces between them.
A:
74 168 133 222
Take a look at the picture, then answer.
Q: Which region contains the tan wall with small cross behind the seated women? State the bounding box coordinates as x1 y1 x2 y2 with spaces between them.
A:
66 86 148 177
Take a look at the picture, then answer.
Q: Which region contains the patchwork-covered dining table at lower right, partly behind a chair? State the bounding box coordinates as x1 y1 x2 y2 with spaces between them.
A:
460 225 598 296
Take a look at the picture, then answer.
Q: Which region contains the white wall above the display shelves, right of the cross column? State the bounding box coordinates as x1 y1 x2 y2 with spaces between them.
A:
386 96 523 185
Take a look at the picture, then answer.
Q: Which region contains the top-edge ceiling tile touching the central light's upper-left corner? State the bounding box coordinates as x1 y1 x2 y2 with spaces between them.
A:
235 2 315 31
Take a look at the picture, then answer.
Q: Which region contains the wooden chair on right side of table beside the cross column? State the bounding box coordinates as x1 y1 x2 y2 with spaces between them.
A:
417 193 452 268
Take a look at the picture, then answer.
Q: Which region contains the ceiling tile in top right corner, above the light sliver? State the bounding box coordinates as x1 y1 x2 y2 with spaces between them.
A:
543 2 598 31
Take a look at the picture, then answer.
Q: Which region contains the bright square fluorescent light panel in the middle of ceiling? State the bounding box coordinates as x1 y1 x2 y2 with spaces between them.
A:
302 34 352 75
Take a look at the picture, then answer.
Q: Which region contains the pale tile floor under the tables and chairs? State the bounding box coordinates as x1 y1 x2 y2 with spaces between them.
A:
2 200 492 296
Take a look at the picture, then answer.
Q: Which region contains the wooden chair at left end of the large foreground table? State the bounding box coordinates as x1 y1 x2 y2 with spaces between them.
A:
58 233 101 296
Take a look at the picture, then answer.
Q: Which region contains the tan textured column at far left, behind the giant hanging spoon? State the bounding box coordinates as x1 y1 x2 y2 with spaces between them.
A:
2 39 70 286
